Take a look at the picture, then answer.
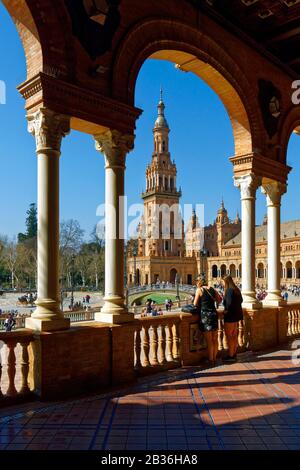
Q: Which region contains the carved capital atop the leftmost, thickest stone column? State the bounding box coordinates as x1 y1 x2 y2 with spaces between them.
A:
27 108 70 154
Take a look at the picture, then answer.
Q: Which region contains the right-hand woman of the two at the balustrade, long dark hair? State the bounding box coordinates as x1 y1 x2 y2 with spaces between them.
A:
223 276 243 362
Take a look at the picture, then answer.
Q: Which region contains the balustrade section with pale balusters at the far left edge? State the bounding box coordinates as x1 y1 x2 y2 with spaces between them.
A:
0 330 34 404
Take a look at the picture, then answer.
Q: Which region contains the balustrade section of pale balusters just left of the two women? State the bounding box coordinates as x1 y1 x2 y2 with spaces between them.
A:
134 315 181 371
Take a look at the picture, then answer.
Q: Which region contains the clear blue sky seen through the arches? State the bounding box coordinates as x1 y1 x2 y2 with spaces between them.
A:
0 3 300 241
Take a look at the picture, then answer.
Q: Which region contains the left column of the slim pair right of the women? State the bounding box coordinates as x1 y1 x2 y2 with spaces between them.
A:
234 173 261 309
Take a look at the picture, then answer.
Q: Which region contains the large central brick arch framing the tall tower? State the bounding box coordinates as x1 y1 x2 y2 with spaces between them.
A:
112 18 263 155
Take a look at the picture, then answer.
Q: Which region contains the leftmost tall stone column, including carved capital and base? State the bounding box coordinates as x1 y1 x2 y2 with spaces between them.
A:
26 108 70 331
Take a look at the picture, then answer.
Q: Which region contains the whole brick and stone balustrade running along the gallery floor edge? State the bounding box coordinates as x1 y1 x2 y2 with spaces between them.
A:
0 303 300 403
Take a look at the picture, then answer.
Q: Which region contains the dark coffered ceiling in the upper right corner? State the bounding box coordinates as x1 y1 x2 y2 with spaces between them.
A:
190 0 300 74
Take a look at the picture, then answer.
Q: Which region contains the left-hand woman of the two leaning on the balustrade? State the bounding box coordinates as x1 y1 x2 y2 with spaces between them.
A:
194 276 222 367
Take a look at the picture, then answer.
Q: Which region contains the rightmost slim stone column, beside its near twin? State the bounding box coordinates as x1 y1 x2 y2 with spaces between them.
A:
261 180 286 306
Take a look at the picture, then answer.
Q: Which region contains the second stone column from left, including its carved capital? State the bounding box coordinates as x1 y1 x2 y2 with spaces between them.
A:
95 130 134 324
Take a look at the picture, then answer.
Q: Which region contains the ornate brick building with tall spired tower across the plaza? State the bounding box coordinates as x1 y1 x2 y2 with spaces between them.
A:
127 92 300 288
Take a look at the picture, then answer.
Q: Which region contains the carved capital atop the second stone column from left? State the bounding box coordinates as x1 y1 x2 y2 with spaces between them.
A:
94 130 135 168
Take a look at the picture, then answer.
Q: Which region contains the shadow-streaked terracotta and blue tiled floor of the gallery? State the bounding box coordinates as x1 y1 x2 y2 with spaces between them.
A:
0 348 300 450
